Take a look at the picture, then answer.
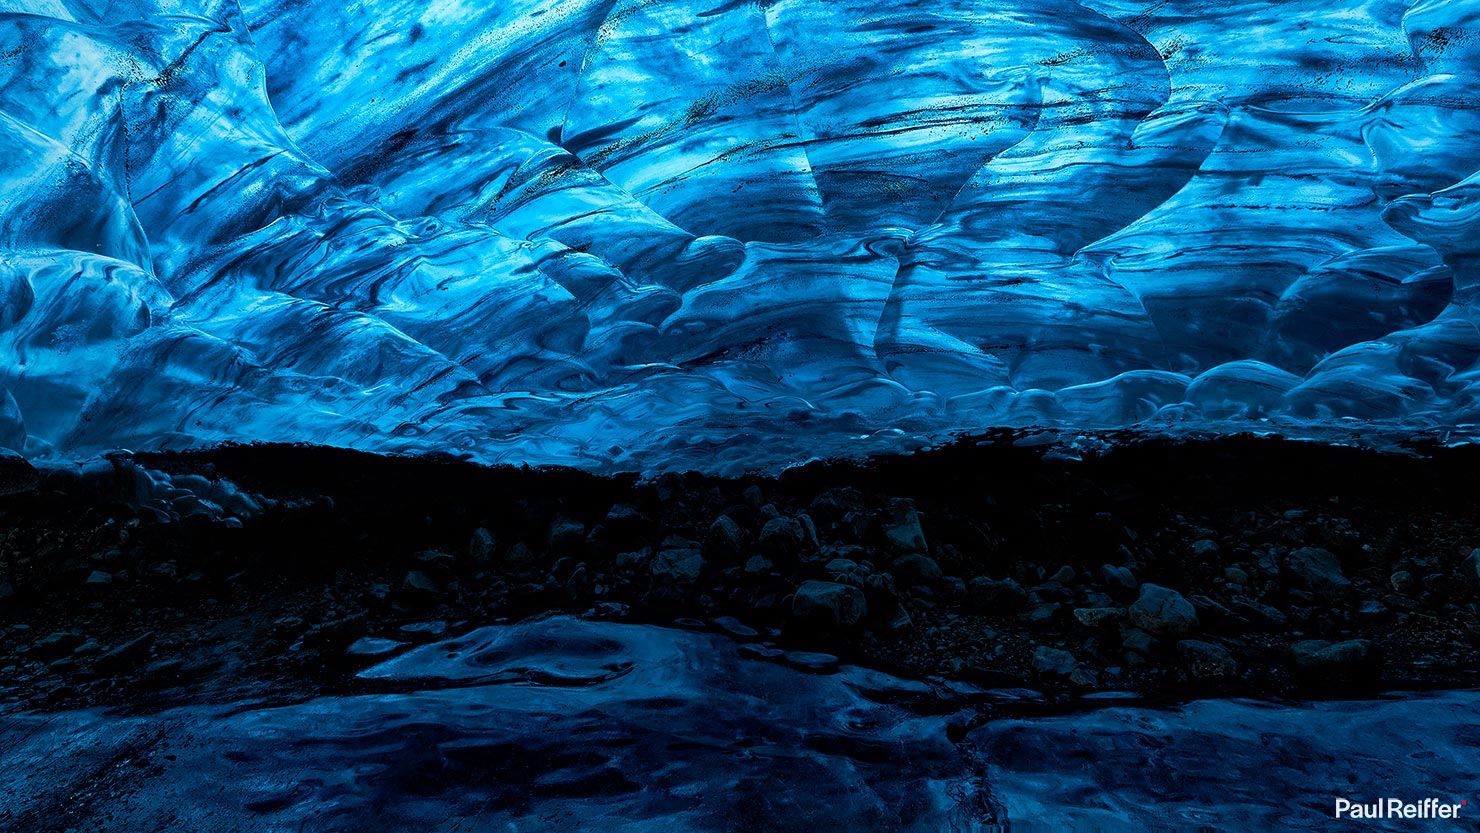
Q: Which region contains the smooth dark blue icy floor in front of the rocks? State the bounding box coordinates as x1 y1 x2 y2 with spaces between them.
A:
0 617 1480 833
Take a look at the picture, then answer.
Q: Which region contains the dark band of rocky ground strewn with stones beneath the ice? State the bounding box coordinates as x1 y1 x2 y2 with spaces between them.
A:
0 432 1480 710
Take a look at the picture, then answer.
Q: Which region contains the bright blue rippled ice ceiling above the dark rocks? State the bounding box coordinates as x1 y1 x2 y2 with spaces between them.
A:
0 0 1480 469
